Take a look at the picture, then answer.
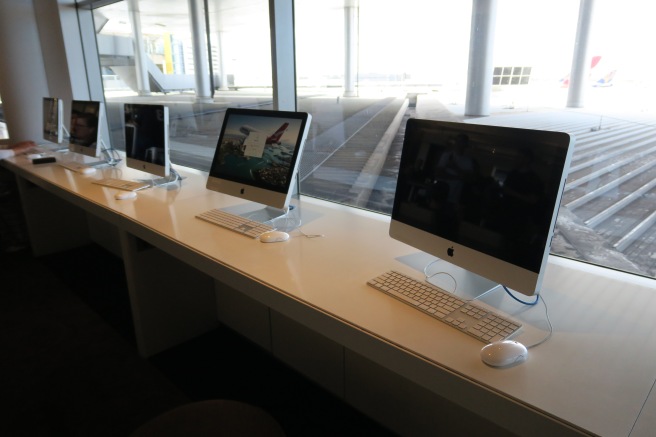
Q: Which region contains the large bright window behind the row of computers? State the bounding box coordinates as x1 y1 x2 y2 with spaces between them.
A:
95 0 656 276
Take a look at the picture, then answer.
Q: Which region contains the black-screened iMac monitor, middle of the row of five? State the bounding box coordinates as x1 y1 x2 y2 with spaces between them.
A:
123 103 170 177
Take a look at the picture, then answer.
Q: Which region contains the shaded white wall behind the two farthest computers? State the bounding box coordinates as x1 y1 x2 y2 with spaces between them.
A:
0 0 109 142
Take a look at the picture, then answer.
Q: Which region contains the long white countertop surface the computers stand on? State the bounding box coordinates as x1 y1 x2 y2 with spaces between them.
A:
3 152 656 436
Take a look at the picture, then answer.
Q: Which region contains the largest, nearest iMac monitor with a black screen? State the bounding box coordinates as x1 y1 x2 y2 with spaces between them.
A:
389 119 574 296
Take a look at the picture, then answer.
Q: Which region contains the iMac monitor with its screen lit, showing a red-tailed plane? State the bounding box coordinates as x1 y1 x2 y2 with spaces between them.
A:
207 108 312 220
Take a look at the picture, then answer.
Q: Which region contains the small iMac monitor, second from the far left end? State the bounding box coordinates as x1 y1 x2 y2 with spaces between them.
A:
68 100 104 158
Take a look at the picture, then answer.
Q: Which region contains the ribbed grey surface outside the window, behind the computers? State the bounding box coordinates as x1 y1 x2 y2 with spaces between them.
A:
100 91 656 276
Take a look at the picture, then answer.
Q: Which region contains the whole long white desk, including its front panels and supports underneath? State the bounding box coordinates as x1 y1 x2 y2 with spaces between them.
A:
3 152 656 436
